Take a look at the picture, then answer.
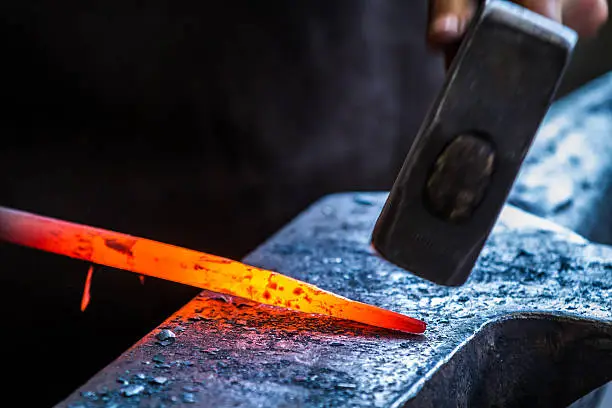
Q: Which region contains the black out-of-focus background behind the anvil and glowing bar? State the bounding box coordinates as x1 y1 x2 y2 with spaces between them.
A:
0 0 612 406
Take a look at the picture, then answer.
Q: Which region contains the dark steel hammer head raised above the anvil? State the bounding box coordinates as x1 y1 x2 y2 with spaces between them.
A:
372 0 577 286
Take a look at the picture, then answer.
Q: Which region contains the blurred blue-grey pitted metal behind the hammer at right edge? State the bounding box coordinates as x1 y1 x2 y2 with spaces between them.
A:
509 73 612 244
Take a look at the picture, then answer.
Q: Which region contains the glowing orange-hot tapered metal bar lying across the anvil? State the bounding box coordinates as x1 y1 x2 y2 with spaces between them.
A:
0 207 426 333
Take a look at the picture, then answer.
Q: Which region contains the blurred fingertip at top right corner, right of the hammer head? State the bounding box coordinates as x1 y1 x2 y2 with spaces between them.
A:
562 0 608 37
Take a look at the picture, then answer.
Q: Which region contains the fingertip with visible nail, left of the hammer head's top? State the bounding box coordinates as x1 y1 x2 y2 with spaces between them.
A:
428 0 476 47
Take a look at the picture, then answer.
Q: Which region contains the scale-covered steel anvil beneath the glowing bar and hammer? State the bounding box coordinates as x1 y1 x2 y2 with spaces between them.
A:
59 193 612 408
